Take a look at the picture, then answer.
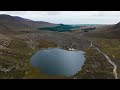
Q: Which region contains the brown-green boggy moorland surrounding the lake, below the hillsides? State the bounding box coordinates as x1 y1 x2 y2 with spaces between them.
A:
0 31 120 79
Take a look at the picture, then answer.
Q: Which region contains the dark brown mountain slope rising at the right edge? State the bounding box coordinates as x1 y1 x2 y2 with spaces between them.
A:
86 23 120 38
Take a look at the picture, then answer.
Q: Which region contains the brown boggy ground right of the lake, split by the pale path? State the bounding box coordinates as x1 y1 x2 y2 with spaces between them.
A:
74 34 120 79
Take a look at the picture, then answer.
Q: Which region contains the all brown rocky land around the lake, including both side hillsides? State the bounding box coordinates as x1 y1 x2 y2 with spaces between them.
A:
0 15 120 79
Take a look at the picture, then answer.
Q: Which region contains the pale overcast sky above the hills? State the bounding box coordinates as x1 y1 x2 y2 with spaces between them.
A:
0 11 120 24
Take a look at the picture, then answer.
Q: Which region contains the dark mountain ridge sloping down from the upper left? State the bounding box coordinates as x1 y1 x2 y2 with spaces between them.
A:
0 14 57 30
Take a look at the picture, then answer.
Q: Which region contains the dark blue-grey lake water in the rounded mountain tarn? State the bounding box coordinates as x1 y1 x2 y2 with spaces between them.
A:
30 48 85 76
